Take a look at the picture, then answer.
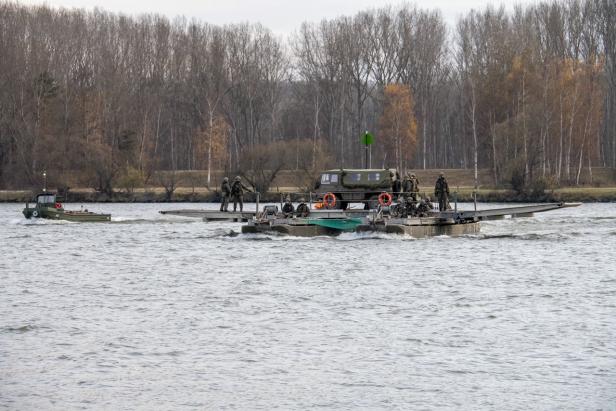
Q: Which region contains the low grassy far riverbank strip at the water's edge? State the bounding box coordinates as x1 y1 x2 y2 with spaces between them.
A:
0 187 616 203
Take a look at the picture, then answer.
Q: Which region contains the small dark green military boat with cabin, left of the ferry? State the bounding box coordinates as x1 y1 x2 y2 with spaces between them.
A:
23 191 111 222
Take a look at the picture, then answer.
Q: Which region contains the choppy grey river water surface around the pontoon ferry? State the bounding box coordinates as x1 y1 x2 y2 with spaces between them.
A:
0 204 616 410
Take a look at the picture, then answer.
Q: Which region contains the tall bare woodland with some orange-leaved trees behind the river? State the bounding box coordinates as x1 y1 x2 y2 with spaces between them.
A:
0 0 616 196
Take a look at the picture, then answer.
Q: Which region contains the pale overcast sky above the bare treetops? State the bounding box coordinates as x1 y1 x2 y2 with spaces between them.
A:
18 0 534 34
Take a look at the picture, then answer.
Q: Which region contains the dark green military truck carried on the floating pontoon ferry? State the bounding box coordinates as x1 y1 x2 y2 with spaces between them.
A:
315 168 400 210
